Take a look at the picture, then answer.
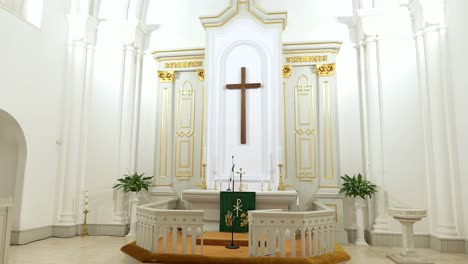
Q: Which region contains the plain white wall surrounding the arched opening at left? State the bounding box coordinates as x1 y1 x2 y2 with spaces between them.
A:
0 0 67 229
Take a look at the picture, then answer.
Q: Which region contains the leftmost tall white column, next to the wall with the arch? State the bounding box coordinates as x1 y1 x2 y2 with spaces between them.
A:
57 14 97 225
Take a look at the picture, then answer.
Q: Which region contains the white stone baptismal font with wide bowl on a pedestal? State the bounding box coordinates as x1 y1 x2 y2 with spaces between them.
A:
387 208 434 264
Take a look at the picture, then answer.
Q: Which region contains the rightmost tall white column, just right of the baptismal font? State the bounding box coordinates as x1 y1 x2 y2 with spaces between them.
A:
423 27 457 236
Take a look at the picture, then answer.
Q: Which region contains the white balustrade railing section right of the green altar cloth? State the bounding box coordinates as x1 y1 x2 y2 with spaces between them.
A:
249 203 336 257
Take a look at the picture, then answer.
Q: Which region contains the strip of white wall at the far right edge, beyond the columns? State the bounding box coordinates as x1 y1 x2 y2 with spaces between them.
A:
447 0 468 239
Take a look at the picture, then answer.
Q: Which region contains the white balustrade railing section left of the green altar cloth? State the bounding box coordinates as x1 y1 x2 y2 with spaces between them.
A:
136 199 204 254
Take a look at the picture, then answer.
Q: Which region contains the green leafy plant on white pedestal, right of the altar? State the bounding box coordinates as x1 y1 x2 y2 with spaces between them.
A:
340 173 378 246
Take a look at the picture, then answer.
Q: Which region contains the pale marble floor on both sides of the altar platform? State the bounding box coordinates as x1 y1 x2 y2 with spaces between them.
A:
8 236 468 264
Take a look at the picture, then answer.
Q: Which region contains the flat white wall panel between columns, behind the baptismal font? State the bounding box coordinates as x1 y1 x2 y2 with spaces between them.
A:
379 38 429 233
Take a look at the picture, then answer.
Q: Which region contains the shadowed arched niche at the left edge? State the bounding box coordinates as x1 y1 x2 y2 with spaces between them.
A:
0 109 26 230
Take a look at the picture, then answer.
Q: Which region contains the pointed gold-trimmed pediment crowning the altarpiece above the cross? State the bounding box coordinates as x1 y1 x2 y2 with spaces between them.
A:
200 0 288 30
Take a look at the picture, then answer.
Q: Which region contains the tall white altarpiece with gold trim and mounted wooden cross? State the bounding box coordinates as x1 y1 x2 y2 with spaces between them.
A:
152 0 346 241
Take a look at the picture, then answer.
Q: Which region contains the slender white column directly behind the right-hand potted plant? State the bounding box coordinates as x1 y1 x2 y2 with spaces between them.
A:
365 36 388 232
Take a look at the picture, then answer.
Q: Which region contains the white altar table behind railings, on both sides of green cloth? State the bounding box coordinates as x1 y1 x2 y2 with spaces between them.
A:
182 190 299 231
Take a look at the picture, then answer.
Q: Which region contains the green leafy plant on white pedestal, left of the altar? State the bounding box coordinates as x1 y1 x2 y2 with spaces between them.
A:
112 172 153 237
